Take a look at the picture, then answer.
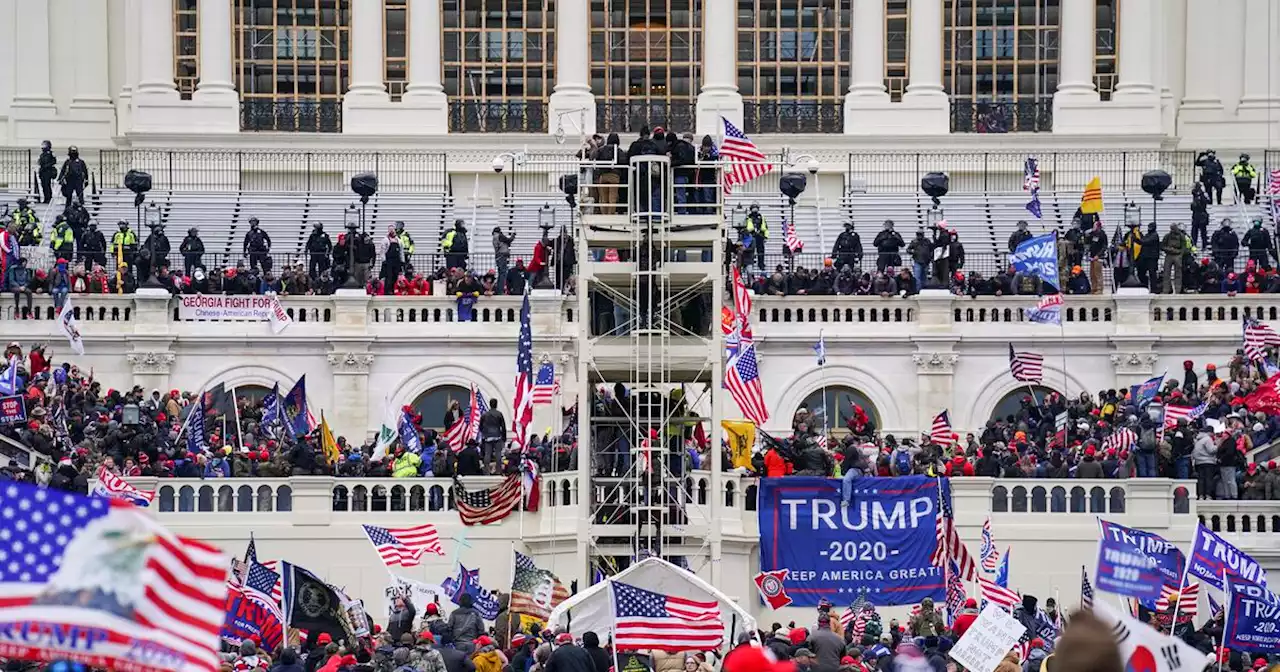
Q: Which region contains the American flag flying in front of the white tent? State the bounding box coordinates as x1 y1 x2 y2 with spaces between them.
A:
609 581 724 653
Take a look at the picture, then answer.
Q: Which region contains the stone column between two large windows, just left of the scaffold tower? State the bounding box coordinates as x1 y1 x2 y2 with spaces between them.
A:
547 0 593 136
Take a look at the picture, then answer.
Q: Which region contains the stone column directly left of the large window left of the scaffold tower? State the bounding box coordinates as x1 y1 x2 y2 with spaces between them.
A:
401 0 449 133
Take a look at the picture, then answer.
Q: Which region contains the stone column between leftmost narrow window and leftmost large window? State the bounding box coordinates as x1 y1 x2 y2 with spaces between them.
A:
191 0 239 133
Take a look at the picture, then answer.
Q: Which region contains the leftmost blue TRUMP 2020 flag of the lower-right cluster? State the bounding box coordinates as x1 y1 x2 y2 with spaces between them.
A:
1096 520 1185 600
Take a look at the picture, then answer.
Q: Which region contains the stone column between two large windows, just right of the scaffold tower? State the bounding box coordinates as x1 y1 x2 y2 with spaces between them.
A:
696 0 745 136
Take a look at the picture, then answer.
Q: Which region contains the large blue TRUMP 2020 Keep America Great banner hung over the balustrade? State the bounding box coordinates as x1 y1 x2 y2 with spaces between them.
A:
758 476 951 607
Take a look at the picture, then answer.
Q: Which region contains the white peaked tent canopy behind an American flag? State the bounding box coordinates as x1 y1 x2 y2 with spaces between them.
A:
547 558 755 646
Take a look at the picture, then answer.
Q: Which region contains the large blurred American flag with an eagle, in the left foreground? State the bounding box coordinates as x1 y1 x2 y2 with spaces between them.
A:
0 483 229 671
